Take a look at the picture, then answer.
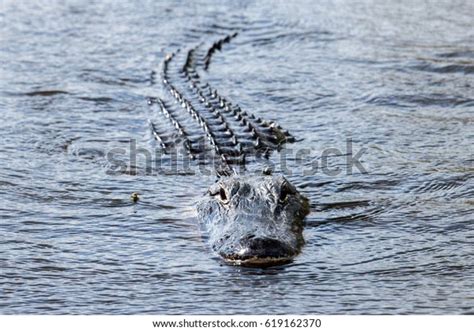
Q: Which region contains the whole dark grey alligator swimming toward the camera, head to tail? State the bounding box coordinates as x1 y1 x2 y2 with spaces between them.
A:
148 32 309 267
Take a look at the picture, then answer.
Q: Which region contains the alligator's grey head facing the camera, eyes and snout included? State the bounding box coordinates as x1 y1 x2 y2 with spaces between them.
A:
197 175 309 266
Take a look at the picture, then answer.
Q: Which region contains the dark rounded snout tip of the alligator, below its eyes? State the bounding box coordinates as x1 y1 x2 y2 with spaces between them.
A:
221 238 297 266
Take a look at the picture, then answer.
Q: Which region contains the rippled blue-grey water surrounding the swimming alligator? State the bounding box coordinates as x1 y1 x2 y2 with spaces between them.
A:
0 1 474 314
